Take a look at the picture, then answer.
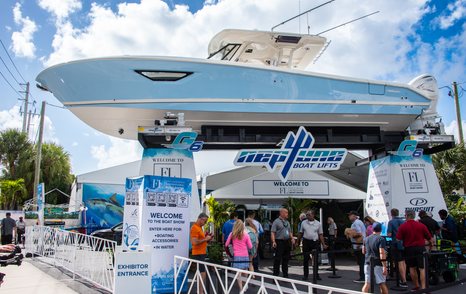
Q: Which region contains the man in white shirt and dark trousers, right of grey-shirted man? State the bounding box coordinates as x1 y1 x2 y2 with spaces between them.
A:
298 210 327 281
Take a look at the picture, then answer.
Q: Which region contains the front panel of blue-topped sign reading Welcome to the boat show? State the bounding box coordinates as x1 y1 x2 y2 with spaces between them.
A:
142 176 193 294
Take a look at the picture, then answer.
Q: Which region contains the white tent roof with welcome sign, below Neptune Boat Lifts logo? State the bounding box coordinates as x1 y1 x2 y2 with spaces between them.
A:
211 167 366 200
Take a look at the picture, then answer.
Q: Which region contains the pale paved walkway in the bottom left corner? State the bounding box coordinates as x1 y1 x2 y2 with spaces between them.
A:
0 259 78 294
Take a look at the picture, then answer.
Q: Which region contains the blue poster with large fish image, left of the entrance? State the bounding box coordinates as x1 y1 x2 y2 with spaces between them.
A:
82 183 125 232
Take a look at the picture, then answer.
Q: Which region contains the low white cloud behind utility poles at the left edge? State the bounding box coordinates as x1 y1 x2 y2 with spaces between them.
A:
0 105 59 143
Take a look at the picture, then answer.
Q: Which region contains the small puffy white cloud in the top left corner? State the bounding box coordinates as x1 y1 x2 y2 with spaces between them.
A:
11 3 37 58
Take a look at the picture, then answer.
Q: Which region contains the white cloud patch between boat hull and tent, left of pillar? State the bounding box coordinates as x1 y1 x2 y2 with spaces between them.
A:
91 137 142 169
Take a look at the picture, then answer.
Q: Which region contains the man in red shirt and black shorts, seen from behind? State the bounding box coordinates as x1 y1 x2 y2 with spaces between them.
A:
396 210 434 290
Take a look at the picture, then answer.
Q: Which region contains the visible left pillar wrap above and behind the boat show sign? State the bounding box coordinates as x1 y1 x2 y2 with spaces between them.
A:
139 148 201 222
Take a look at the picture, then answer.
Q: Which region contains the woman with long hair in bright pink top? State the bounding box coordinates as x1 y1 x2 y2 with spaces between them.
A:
225 220 252 292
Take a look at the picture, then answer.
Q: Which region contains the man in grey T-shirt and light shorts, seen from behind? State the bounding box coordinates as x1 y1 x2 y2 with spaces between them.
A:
362 222 388 294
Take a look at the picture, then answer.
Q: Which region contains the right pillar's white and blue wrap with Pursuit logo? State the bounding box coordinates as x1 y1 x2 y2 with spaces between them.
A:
365 155 446 233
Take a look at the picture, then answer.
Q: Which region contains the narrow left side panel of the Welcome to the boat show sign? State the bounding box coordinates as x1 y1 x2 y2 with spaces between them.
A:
121 177 144 251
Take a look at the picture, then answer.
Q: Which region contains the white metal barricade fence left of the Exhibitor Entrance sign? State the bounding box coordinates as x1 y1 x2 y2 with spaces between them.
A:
25 226 116 291
